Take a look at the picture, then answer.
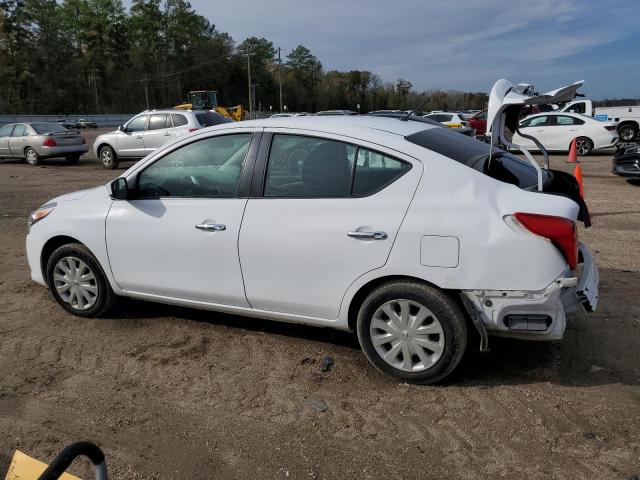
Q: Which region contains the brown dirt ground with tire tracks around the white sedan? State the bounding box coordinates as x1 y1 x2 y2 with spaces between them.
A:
0 129 640 479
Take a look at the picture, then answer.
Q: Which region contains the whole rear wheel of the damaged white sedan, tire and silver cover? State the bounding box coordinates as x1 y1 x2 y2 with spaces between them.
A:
357 281 467 383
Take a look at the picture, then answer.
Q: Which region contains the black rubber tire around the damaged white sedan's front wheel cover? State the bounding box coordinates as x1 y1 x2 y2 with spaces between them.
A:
46 243 115 317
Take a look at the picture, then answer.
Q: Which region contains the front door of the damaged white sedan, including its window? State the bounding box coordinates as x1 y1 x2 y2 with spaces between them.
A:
106 130 259 306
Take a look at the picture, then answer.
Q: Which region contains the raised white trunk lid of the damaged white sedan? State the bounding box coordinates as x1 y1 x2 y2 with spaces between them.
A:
487 78 584 131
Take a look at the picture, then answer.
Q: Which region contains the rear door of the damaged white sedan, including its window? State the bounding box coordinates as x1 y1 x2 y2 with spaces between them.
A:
239 130 422 319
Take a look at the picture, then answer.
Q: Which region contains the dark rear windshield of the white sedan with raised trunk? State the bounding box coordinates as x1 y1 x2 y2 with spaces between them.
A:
405 128 551 189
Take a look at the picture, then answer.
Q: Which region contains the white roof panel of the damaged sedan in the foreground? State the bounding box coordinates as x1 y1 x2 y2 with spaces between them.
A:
242 115 441 137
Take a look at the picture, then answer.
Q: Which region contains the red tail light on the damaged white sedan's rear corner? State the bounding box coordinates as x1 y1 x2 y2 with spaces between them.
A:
514 212 578 269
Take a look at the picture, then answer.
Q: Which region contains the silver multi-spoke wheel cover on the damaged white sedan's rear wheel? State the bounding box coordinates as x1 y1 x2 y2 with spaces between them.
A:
369 300 445 372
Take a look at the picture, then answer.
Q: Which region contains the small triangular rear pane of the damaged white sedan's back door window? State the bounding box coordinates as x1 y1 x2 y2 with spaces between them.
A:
353 148 411 196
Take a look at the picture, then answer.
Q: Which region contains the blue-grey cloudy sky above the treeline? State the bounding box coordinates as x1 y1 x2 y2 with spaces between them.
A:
182 0 640 99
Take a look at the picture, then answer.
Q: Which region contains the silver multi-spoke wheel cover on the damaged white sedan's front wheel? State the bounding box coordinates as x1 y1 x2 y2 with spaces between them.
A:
53 257 98 310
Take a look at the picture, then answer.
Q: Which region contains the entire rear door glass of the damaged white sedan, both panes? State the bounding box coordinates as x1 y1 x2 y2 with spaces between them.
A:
264 135 411 198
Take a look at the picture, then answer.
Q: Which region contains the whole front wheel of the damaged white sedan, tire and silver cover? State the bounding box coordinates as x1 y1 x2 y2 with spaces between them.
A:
46 243 115 317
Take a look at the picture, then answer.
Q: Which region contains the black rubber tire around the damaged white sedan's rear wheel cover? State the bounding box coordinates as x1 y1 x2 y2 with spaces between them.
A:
357 281 467 384
